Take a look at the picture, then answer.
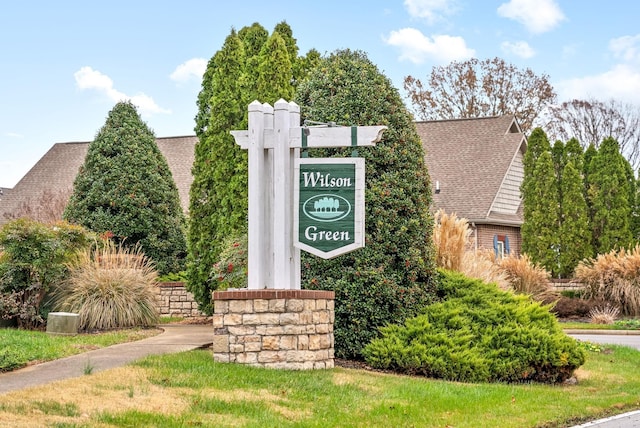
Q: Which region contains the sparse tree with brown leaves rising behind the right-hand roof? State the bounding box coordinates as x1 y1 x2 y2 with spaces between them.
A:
404 58 556 133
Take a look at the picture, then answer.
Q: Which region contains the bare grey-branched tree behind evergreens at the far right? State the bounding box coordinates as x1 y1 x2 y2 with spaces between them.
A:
540 98 640 170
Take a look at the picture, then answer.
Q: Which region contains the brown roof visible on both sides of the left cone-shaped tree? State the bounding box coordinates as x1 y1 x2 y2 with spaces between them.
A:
0 136 198 224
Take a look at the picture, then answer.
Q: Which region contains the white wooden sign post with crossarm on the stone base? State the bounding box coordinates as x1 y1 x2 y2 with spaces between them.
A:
231 99 387 290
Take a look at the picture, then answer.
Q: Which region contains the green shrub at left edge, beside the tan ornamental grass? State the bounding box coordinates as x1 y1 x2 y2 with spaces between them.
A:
0 218 92 328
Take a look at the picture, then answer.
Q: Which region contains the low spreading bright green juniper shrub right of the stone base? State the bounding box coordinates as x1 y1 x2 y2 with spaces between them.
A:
364 271 585 383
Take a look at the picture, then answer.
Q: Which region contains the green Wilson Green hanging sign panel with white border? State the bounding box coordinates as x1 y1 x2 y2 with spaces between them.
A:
294 158 364 258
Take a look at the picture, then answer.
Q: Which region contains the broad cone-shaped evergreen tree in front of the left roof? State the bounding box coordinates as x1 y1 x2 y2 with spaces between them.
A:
64 102 186 274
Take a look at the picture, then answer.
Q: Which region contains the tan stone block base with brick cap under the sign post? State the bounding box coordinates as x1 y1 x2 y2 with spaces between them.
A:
213 289 335 370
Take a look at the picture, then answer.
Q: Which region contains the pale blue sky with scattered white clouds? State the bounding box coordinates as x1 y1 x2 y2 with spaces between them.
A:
0 0 640 187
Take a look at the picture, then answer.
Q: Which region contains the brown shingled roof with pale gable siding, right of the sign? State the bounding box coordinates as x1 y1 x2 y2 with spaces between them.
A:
416 115 526 225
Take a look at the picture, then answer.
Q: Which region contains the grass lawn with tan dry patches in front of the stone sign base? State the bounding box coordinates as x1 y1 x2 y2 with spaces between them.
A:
0 346 640 428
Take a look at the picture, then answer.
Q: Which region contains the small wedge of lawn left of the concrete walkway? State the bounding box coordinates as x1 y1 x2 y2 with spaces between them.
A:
0 328 160 372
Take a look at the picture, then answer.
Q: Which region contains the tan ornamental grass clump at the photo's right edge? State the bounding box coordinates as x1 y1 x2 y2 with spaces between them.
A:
576 245 640 316
